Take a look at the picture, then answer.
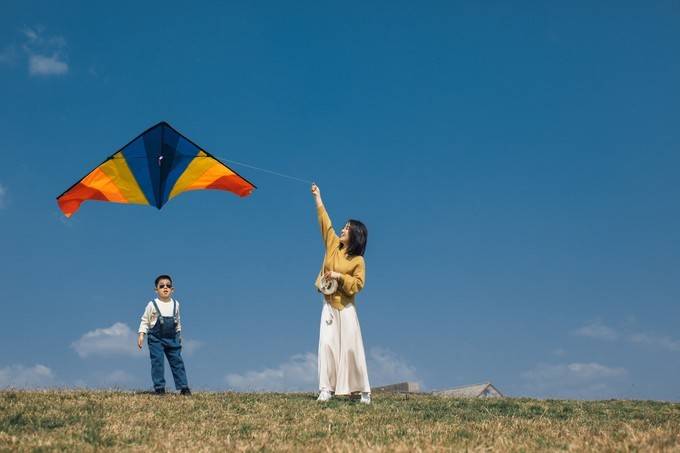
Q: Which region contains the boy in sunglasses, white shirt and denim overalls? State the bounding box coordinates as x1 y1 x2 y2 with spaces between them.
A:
137 275 191 395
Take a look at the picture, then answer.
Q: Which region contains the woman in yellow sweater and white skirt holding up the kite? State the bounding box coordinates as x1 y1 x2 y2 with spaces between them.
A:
312 184 371 404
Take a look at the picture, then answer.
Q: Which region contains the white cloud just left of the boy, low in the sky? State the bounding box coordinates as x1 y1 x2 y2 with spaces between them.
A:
71 322 139 358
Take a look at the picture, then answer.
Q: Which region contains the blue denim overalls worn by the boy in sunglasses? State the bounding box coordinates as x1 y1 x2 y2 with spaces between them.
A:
147 299 189 390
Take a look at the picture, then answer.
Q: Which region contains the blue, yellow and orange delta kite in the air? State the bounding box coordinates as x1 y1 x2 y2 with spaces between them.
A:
57 122 255 217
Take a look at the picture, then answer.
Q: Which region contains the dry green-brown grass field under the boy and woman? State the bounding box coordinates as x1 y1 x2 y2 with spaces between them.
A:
0 390 680 451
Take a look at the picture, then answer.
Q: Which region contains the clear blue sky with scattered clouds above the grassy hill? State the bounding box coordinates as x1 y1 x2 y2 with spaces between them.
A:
0 1 680 401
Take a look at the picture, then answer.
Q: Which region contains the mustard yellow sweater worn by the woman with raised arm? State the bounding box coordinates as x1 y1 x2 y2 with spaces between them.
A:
317 205 366 310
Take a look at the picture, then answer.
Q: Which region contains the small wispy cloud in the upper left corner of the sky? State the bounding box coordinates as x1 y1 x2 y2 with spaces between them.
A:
21 27 69 76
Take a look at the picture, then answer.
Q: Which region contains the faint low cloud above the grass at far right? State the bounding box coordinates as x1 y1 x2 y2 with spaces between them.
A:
521 362 628 399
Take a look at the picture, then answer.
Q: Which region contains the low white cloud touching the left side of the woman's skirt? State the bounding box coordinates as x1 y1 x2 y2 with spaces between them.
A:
224 352 317 392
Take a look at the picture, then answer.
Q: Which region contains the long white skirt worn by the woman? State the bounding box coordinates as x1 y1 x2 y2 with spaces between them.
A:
319 301 371 395
